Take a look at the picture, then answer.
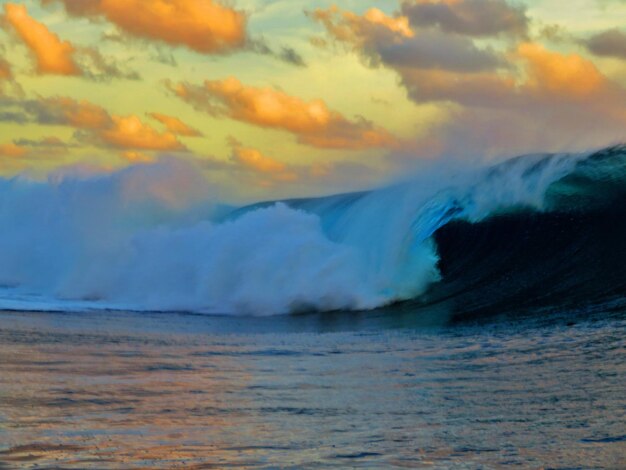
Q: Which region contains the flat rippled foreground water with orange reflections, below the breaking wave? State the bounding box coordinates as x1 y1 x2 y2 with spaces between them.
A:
0 313 626 468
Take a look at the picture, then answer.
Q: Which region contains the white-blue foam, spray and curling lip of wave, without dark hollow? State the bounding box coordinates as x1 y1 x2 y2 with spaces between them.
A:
0 147 626 315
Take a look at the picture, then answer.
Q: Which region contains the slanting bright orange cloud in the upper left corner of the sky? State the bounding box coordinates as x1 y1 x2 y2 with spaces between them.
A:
4 3 82 75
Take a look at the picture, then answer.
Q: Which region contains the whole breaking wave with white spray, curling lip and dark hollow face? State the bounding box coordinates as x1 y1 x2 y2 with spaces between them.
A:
0 146 626 315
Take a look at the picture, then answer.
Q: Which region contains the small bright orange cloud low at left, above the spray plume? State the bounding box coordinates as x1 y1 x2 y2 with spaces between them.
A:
98 116 185 150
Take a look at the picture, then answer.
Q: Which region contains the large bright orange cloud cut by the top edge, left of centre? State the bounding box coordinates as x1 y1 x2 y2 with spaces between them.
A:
42 0 246 54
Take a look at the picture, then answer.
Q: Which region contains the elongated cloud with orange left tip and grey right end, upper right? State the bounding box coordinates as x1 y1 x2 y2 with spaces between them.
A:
308 7 506 72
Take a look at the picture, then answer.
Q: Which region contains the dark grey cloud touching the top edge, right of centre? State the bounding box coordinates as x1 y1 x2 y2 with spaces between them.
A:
401 0 529 36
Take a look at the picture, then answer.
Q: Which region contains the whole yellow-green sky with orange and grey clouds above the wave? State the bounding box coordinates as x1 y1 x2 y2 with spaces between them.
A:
0 0 626 200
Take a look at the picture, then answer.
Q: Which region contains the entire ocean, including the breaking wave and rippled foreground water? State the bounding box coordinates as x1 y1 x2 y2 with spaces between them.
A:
0 146 626 469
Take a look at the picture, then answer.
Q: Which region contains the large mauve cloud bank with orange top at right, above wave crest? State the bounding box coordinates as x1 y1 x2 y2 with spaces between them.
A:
403 43 626 158
